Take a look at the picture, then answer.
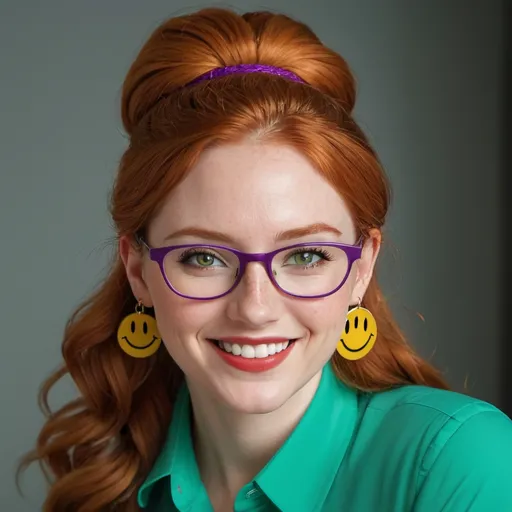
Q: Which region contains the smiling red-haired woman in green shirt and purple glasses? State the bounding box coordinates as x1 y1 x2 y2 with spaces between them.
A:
22 9 512 512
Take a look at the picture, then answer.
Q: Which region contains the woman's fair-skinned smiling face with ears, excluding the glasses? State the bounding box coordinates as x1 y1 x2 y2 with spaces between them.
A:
120 141 378 413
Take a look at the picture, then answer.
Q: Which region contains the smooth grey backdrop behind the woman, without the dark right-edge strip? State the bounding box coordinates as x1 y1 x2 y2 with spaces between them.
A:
0 0 510 512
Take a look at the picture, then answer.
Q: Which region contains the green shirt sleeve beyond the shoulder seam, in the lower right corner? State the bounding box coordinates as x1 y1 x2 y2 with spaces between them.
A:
413 410 512 512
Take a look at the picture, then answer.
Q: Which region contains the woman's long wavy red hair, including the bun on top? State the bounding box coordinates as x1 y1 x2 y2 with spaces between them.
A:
22 9 447 512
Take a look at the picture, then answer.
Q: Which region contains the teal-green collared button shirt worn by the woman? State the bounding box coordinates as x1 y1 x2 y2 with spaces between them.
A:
138 364 512 512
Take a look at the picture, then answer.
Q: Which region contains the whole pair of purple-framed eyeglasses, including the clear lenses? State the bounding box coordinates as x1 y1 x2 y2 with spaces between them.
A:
136 235 362 300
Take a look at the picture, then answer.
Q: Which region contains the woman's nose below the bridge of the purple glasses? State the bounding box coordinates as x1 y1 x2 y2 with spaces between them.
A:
227 262 283 327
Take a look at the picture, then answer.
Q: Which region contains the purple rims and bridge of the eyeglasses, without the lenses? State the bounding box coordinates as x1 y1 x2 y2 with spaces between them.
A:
135 235 363 300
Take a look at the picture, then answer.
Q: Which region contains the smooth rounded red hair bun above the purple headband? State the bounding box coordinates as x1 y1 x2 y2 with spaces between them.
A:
121 9 355 134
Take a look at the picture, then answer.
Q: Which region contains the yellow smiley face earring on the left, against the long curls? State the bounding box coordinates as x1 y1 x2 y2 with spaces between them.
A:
117 313 162 358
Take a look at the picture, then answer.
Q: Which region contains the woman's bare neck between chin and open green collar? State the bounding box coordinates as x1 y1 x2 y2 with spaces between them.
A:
189 372 321 499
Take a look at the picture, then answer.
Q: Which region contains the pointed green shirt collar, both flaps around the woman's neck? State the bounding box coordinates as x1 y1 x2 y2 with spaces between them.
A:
138 363 357 512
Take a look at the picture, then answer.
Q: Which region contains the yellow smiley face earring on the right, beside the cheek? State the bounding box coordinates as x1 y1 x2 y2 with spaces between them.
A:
337 307 377 361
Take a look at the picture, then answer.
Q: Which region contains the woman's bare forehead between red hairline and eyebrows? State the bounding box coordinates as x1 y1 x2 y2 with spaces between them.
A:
151 141 354 243
